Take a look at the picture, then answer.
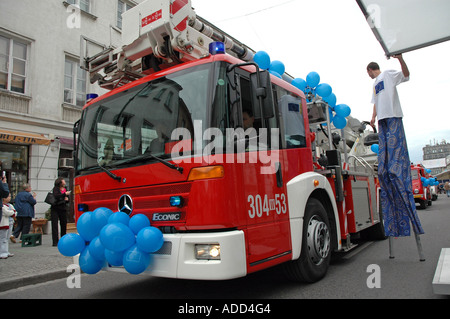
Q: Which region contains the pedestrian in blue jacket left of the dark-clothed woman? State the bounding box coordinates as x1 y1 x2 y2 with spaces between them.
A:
13 183 36 238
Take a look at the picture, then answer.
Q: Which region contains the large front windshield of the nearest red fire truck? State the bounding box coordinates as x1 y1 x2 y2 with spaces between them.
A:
77 64 228 170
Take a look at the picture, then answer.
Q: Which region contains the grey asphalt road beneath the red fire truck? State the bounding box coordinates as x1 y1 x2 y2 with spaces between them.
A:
0 195 450 302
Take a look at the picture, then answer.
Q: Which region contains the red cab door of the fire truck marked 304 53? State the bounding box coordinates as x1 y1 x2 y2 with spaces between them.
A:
231 69 291 272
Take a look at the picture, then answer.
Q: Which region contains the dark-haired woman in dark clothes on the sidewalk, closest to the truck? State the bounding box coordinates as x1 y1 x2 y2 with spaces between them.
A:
51 178 70 246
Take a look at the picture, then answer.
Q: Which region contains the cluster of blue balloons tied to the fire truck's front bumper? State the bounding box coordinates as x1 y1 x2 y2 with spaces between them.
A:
58 207 164 275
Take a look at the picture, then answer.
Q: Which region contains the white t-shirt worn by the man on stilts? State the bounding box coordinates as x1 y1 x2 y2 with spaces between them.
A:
372 70 409 121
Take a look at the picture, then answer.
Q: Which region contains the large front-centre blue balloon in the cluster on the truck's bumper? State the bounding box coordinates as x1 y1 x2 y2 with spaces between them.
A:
100 223 136 252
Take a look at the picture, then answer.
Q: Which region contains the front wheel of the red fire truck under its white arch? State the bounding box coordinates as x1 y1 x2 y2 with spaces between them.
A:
284 198 331 283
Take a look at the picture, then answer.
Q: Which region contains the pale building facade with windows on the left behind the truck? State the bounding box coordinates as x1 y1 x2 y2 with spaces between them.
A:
0 0 142 218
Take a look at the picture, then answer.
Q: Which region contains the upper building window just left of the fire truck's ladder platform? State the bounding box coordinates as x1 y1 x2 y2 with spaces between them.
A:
64 57 87 106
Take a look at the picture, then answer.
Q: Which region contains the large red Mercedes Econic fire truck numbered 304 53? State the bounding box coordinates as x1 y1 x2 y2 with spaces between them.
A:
74 0 384 282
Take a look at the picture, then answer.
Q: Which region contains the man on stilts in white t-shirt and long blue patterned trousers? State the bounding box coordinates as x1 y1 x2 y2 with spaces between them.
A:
367 54 424 237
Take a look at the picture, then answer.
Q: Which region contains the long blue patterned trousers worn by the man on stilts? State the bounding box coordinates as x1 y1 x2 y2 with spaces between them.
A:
378 118 424 237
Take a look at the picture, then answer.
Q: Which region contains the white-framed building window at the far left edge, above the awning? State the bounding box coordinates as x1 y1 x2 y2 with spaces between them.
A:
0 35 28 93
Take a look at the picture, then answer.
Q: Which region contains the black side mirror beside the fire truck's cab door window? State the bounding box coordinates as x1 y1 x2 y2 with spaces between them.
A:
250 70 275 119
